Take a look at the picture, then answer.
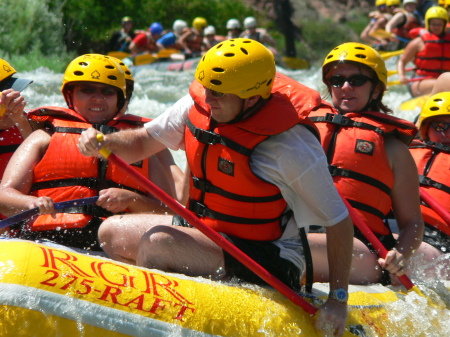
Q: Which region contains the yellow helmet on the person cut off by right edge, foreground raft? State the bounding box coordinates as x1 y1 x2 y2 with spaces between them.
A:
417 92 450 140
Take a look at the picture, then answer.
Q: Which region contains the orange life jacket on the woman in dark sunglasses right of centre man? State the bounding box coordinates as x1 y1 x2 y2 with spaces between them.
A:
310 111 417 235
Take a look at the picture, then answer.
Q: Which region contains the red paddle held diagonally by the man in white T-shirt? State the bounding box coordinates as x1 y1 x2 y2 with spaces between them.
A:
97 134 318 315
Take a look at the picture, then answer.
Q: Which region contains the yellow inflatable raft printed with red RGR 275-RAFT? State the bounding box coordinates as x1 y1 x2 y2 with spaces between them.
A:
0 239 448 337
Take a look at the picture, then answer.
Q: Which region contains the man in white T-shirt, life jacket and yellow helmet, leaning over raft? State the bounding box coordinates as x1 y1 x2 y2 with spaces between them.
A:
78 38 353 336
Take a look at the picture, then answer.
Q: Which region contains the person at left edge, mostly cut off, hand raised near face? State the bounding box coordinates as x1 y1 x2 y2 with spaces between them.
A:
0 59 33 223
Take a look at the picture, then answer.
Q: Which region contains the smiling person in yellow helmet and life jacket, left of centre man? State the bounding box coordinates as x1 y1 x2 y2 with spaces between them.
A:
0 54 185 251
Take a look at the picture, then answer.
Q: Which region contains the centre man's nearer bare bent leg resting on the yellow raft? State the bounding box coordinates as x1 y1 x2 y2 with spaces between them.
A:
136 226 225 279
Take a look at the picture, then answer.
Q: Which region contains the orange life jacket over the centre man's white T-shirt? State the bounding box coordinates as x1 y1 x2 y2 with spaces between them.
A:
185 74 331 241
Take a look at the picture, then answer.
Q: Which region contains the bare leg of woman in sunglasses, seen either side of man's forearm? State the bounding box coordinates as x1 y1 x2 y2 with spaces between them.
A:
308 233 381 284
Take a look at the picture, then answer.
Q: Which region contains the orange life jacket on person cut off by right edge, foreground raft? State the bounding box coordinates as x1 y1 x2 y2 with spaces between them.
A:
409 141 450 235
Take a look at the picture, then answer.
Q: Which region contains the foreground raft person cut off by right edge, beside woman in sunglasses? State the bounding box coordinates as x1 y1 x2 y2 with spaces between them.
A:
410 92 450 254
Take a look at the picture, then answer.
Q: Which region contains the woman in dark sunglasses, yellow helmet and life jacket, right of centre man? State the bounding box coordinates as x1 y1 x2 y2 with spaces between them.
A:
308 42 435 284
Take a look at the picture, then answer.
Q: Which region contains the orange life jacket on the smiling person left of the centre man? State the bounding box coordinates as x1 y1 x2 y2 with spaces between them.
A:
29 107 149 231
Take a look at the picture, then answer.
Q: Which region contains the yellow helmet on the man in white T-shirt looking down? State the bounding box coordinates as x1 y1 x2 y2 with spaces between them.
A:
195 38 276 99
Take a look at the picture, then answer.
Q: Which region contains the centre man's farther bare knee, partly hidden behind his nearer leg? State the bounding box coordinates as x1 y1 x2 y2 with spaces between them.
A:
98 214 172 264
